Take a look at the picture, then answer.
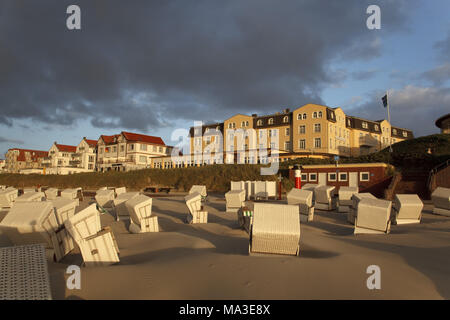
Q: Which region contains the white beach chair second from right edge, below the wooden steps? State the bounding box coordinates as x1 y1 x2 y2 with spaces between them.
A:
391 194 423 224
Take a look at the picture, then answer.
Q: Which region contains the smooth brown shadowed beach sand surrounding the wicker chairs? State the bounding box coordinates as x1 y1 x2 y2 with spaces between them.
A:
0 194 450 300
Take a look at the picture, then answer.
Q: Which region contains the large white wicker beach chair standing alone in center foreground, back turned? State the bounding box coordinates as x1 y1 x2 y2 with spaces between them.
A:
249 203 300 255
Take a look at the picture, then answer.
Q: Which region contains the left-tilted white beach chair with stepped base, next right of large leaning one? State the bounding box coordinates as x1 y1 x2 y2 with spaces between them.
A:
125 195 159 233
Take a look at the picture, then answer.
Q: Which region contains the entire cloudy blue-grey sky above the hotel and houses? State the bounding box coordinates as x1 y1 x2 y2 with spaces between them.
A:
0 0 450 157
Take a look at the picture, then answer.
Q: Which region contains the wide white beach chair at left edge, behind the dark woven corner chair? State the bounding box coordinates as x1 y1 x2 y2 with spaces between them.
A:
0 201 59 248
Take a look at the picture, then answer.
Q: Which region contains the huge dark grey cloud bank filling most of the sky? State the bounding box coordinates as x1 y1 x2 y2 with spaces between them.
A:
0 0 409 131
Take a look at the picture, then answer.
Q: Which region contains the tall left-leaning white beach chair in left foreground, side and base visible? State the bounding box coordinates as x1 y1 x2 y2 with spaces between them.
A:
64 204 120 266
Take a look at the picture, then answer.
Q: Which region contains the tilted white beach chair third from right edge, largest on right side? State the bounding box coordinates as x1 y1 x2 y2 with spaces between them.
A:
354 197 392 234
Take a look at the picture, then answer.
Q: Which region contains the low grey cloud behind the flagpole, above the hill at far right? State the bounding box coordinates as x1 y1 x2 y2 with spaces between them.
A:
344 86 450 136
